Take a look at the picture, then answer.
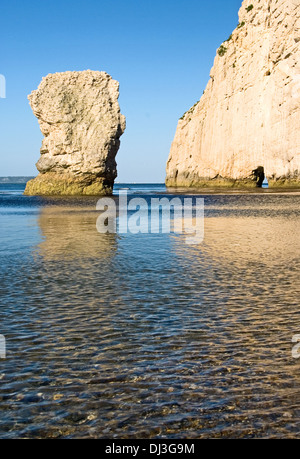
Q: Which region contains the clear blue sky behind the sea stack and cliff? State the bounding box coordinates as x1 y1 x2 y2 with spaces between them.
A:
0 0 242 182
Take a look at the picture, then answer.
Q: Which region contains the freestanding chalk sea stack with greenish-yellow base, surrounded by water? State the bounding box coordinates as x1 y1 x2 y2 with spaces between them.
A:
25 70 125 195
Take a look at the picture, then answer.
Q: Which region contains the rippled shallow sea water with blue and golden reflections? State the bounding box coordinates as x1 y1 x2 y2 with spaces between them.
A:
0 185 300 438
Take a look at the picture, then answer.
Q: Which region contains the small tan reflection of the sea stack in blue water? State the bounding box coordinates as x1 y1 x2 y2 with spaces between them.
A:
39 206 117 260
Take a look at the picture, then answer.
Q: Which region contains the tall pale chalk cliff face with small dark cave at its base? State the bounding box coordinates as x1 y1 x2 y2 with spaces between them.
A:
166 0 300 186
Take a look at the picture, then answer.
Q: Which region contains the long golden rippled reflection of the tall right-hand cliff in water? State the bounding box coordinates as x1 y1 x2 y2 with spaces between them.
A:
172 196 300 366
